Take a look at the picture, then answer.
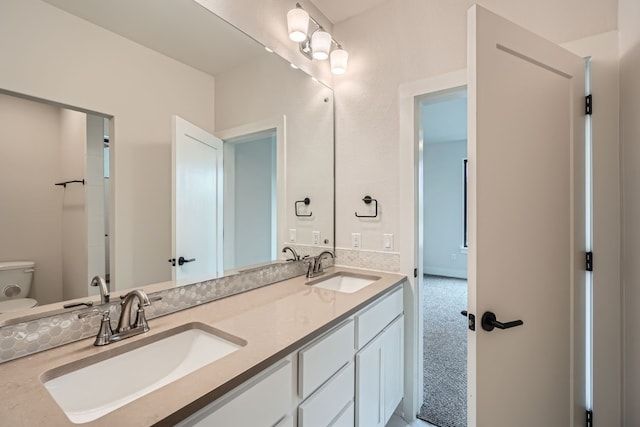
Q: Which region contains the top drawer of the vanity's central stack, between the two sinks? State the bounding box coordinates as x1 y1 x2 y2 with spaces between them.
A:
298 320 355 399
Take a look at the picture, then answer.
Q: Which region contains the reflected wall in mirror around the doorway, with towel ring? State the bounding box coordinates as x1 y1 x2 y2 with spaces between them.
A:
215 55 336 251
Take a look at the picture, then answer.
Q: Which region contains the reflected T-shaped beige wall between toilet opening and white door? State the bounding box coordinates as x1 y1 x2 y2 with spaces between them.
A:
0 0 214 289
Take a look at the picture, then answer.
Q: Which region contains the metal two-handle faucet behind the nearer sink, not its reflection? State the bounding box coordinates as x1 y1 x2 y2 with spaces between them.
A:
78 289 162 346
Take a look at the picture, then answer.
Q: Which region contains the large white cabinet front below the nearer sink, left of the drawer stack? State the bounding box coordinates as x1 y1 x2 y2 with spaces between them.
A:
178 360 293 427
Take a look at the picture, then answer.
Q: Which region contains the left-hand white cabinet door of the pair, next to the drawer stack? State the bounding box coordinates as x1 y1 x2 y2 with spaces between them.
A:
356 335 385 427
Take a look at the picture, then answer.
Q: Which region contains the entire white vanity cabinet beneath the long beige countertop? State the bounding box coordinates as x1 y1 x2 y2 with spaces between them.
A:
178 286 404 427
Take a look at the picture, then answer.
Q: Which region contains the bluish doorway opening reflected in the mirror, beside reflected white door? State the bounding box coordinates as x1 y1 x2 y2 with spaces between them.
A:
224 129 277 270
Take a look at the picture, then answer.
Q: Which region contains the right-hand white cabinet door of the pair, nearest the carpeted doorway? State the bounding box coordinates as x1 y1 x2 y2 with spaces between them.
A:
382 316 404 423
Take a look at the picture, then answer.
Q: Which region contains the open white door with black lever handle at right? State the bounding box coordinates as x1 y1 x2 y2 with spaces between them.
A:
468 6 585 427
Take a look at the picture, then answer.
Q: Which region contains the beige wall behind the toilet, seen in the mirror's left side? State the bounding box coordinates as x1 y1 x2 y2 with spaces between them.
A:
0 94 64 304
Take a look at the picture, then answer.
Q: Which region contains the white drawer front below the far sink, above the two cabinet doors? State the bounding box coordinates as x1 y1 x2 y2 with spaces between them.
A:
355 286 403 349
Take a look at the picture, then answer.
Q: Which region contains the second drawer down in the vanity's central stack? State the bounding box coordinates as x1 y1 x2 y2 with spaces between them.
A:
298 363 355 427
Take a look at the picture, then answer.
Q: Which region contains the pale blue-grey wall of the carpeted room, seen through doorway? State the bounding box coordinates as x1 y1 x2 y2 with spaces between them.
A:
423 140 467 278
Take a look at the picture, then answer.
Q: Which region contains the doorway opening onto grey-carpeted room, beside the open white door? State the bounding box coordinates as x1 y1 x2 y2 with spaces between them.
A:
418 87 467 427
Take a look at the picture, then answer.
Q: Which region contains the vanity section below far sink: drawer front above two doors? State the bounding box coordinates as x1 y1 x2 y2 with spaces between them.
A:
355 289 404 427
